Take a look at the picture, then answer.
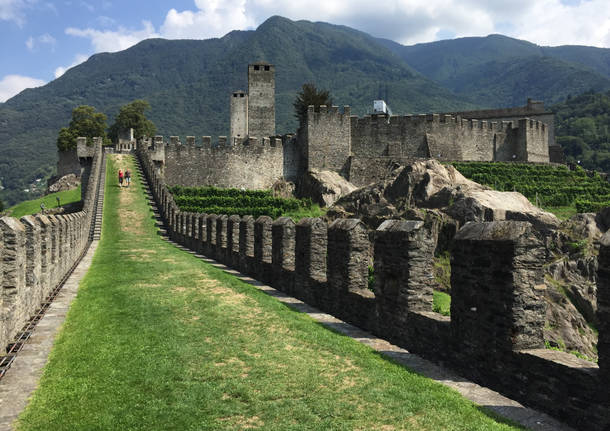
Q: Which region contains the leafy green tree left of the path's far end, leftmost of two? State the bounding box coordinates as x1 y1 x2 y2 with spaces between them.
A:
57 105 108 151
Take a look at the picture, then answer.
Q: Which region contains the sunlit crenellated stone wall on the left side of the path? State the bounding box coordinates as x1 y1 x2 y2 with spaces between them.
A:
0 139 102 348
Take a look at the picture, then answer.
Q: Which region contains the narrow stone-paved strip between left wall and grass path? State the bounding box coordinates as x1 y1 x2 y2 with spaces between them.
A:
0 155 106 431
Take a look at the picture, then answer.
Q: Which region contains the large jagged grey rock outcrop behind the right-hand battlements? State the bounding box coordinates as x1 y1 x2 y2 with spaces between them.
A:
327 160 610 359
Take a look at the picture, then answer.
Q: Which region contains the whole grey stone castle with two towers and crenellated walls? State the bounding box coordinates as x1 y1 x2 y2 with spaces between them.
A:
141 63 561 189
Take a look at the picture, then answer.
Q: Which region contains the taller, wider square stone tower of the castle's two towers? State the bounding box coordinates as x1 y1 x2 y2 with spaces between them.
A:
247 63 275 139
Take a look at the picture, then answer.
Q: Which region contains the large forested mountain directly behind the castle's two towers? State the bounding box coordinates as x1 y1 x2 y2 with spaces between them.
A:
0 17 474 203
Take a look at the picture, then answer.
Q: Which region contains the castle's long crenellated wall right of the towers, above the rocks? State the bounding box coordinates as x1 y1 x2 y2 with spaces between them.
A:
303 106 549 186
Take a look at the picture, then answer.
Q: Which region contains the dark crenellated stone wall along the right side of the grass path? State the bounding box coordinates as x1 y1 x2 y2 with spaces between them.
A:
138 147 610 431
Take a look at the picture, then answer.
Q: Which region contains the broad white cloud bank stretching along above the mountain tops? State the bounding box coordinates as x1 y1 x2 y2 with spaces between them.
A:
59 0 610 52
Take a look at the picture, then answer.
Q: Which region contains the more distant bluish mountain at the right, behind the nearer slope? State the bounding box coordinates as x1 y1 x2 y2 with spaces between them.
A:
380 35 610 107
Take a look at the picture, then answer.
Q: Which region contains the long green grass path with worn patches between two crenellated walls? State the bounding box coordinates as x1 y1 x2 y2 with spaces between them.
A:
18 156 519 431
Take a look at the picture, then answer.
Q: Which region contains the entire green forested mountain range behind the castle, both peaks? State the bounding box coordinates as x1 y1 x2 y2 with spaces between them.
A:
0 16 610 204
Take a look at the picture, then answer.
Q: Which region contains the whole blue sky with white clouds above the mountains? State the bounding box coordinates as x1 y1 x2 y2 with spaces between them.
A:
0 0 610 102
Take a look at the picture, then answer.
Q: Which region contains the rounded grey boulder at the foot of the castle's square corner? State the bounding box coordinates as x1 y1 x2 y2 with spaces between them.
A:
298 170 357 207
